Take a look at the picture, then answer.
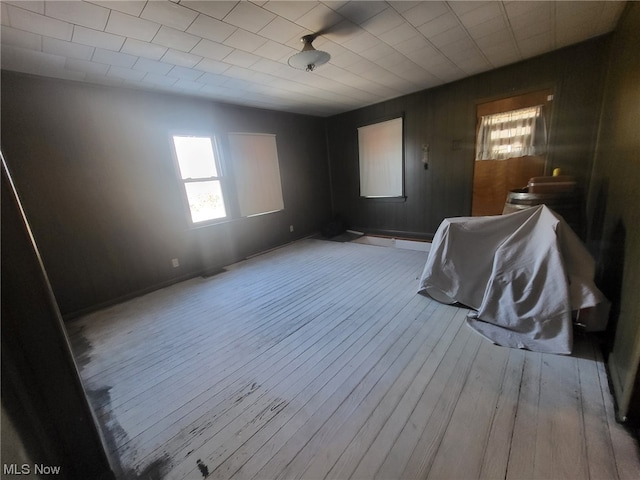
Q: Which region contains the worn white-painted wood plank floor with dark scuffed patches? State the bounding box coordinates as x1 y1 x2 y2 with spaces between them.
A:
68 239 640 480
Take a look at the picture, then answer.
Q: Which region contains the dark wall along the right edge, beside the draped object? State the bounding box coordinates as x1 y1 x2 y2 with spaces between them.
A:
588 2 640 426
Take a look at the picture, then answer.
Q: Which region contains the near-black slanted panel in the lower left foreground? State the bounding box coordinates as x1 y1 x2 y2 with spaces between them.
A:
0 162 113 480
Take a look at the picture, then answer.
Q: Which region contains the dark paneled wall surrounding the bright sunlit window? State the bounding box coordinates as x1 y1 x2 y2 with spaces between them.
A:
2 72 331 314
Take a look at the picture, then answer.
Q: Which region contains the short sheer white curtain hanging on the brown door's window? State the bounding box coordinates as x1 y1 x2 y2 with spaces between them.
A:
476 105 547 160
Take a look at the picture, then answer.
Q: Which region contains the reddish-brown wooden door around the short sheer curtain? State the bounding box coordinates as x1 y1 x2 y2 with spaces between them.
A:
471 89 553 216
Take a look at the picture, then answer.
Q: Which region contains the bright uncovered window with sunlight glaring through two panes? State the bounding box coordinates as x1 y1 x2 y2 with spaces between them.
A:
173 136 227 223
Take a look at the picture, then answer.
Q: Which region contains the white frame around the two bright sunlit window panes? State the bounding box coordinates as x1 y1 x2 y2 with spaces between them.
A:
169 132 232 228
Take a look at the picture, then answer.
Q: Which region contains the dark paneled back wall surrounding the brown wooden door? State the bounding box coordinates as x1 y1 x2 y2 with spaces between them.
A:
328 37 609 237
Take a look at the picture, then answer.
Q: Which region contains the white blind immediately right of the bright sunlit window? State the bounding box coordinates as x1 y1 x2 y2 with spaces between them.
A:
229 133 284 217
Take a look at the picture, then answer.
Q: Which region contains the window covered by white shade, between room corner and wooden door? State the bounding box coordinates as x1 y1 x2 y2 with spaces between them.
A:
358 117 404 198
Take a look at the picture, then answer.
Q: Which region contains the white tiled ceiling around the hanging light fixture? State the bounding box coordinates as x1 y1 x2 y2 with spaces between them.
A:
0 0 625 116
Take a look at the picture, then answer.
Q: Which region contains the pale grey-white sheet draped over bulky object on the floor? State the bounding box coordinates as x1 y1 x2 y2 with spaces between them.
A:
419 205 608 354
